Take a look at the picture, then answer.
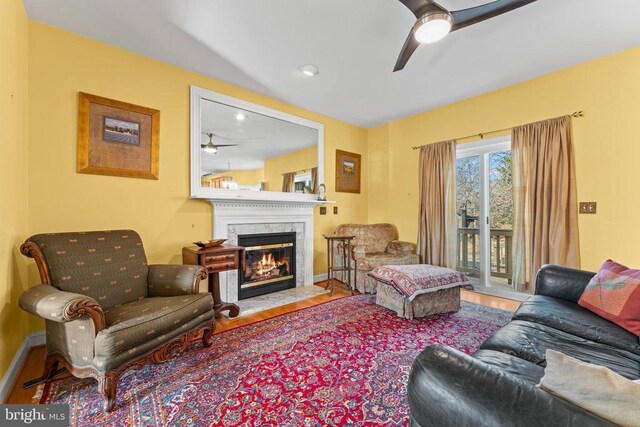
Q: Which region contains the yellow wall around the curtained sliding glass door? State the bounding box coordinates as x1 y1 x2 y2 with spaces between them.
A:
368 48 640 270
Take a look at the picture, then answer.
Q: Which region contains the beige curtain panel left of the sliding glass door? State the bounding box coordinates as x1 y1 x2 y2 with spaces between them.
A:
418 141 456 268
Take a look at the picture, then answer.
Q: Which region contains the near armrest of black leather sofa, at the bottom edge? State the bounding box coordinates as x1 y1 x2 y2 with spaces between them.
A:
407 344 614 427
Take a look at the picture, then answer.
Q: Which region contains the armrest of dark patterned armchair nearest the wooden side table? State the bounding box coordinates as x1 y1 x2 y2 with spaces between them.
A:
147 264 208 297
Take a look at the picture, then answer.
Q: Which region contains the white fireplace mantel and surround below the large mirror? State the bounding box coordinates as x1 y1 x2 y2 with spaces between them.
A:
207 197 332 302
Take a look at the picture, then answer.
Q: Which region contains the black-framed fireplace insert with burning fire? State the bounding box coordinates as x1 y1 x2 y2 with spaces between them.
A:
238 233 296 299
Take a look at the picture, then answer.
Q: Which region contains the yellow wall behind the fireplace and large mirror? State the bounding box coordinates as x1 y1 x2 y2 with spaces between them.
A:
29 21 367 314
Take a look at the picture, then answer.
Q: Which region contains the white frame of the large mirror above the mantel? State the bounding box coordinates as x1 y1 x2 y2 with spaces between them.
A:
190 85 324 202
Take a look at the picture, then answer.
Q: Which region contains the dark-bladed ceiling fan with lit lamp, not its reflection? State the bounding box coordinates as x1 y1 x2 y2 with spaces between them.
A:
393 0 536 72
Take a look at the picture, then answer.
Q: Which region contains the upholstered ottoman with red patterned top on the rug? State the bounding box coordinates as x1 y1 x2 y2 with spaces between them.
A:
369 264 473 319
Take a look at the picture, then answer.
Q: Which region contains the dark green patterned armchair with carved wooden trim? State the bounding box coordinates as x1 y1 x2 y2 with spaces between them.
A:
19 230 215 411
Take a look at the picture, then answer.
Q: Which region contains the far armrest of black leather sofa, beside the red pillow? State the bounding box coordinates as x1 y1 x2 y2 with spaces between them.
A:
535 264 596 303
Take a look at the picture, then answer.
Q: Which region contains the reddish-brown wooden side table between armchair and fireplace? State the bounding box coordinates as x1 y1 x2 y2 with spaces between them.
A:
182 245 245 317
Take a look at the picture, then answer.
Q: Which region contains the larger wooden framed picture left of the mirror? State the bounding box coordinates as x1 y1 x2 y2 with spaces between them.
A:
78 92 160 179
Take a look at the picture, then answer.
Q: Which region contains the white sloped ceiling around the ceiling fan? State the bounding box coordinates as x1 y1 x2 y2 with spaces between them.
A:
24 0 640 127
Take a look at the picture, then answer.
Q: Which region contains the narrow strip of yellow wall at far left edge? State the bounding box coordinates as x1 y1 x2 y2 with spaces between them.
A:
0 0 29 377
